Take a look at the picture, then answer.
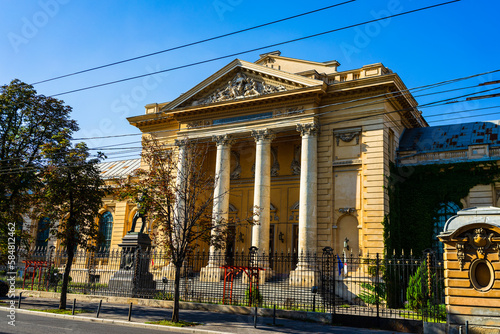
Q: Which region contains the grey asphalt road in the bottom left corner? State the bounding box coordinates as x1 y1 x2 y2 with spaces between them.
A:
0 310 186 334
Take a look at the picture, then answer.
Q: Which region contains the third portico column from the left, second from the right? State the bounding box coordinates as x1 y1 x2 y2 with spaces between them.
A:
252 129 275 281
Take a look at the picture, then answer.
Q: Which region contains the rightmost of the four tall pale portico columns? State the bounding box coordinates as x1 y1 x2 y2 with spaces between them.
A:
290 123 319 287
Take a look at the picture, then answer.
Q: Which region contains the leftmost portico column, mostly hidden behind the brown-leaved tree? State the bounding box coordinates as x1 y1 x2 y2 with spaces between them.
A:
164 139 188 280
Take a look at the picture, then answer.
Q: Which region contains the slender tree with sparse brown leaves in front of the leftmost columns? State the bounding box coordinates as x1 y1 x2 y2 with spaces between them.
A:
119 138 231 322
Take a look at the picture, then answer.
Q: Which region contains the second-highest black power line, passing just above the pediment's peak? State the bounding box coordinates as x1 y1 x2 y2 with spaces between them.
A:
51 0 460 97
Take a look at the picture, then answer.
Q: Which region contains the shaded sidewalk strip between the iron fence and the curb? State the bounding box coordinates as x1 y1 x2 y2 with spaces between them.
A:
0 297 410 334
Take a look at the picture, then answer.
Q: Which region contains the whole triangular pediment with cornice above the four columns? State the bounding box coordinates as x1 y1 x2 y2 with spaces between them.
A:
162 59 323 111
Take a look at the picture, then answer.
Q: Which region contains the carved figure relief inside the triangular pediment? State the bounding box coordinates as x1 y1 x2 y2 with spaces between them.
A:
191 72 287 106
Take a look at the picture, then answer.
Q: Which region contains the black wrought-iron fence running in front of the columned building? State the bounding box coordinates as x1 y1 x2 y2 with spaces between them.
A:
10 248 446 322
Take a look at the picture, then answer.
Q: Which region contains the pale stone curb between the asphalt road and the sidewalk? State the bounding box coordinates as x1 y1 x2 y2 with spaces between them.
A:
0 306 228 334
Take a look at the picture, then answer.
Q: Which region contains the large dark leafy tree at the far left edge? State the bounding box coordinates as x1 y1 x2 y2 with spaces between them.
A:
0 79 78 262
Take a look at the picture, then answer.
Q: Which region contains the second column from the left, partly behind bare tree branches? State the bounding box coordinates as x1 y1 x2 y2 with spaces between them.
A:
200 134 233 282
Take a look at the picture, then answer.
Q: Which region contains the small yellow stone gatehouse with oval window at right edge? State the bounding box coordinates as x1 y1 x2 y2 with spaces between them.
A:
438 207 500 333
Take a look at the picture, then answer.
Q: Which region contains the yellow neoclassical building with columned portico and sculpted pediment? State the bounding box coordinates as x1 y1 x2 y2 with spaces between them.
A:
30 51 500 279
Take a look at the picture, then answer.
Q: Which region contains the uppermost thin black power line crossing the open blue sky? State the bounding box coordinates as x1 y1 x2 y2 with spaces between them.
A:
31 0 356 85
